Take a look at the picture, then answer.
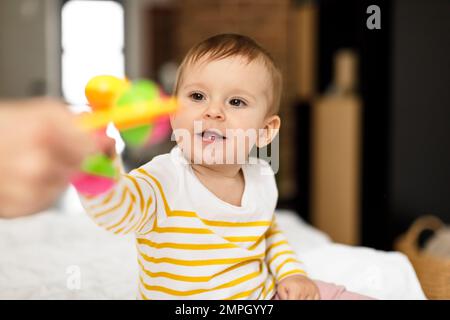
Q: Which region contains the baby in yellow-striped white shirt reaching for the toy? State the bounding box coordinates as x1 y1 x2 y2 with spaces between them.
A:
76 34 372 299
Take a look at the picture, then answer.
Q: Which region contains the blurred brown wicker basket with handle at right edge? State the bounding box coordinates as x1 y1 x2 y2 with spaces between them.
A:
395 216 450 299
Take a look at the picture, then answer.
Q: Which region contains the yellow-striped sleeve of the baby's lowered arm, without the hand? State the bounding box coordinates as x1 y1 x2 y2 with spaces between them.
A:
265 216 306 282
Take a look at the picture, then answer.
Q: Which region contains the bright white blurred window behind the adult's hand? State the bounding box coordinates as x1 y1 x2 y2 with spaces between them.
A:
61 0 125 106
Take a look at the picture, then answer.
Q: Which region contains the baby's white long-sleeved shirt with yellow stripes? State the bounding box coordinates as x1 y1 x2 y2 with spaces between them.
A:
80 147 305 299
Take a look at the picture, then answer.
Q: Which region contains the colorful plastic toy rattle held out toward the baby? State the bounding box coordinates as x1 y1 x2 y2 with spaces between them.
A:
71 75 177 196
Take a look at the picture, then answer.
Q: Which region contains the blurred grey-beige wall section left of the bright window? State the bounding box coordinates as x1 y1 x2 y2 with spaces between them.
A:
0 0 60 97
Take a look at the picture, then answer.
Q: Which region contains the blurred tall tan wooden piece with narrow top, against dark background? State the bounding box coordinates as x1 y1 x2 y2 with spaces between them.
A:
311 50 361 245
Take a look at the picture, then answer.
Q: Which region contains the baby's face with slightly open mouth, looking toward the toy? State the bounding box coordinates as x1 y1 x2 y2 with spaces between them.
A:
171 56 272 164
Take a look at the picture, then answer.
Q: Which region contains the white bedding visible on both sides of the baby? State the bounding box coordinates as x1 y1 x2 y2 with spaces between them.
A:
0 192 425 299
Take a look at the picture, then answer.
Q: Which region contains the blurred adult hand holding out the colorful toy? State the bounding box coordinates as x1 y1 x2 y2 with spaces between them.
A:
0 98 95 218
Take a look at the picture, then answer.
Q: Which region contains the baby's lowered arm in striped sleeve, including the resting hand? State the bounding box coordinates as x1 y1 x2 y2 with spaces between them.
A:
265 217 319 300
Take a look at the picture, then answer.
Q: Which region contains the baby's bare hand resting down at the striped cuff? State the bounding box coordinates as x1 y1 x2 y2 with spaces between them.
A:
277 275 320 300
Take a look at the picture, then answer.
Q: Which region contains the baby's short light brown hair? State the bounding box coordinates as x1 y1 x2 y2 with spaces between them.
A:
173 34 283 116
